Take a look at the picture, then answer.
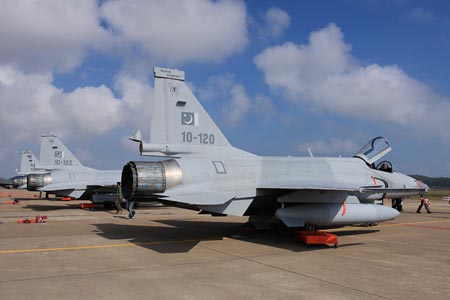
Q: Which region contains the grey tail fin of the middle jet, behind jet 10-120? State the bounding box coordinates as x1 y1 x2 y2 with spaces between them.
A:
39 133 83 169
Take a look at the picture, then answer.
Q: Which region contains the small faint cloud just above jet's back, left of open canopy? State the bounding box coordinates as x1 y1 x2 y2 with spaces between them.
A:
296 138 360 156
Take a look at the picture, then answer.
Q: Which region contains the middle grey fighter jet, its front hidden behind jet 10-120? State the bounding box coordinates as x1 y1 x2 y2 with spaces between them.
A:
27 133 121 199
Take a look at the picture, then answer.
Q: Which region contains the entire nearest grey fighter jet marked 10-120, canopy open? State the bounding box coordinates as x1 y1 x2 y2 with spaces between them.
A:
121 67 428 231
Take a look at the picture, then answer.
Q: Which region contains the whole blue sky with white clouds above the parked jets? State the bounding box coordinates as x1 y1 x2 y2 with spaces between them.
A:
0 0 450 177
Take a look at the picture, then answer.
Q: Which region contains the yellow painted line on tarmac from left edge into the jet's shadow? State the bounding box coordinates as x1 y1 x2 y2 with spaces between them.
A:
0 240 201 254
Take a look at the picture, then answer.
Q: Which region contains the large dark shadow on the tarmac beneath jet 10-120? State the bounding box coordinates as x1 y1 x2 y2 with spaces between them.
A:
95 216 372 254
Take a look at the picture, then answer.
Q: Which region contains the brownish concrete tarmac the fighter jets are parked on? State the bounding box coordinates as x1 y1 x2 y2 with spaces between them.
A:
0 189 450 300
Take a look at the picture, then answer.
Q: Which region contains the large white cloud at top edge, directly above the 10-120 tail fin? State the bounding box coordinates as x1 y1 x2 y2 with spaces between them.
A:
101 0 248 64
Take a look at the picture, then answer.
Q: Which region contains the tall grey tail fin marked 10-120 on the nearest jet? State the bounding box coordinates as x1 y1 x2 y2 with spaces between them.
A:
141 67 231 152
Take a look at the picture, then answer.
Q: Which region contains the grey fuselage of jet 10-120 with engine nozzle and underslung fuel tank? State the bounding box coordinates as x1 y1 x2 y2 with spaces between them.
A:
122 148 424 227
